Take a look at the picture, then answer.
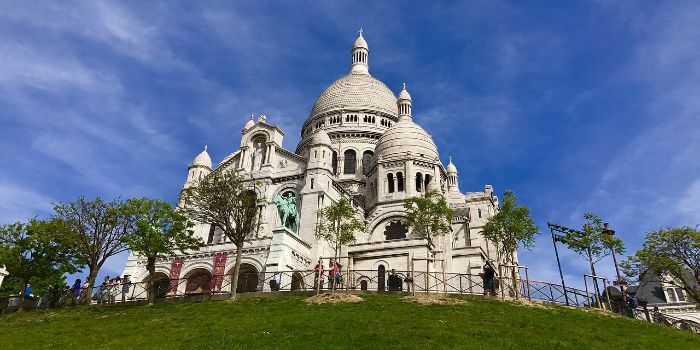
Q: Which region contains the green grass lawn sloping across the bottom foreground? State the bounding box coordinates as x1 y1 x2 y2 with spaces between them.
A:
0 294 700 350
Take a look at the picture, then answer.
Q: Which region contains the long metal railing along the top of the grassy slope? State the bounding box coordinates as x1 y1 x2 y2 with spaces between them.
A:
6 270 595 310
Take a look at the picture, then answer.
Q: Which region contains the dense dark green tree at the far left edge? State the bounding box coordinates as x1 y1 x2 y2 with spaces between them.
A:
0 219 77 311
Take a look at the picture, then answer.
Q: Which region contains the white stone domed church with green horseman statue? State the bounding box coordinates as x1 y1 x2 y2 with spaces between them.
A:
124 32 508 293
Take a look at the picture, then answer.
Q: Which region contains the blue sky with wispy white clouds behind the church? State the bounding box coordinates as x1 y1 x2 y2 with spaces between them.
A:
0 0 700 285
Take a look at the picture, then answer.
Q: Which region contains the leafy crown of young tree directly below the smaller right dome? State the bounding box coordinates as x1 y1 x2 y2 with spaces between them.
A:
403 190 453 250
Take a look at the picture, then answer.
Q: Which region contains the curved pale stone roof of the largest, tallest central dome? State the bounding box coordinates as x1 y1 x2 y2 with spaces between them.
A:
309 73 398 118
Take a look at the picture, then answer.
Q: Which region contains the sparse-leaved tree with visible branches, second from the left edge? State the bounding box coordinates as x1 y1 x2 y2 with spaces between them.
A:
54 197 133 300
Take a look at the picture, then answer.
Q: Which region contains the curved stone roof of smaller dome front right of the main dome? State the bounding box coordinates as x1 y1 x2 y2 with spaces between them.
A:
374 117 438 160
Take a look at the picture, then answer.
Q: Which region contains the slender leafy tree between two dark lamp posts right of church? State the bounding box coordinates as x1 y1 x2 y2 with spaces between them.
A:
559 213 625 297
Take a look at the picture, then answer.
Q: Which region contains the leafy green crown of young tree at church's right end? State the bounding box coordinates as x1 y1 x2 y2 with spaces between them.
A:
482 190 539 263
